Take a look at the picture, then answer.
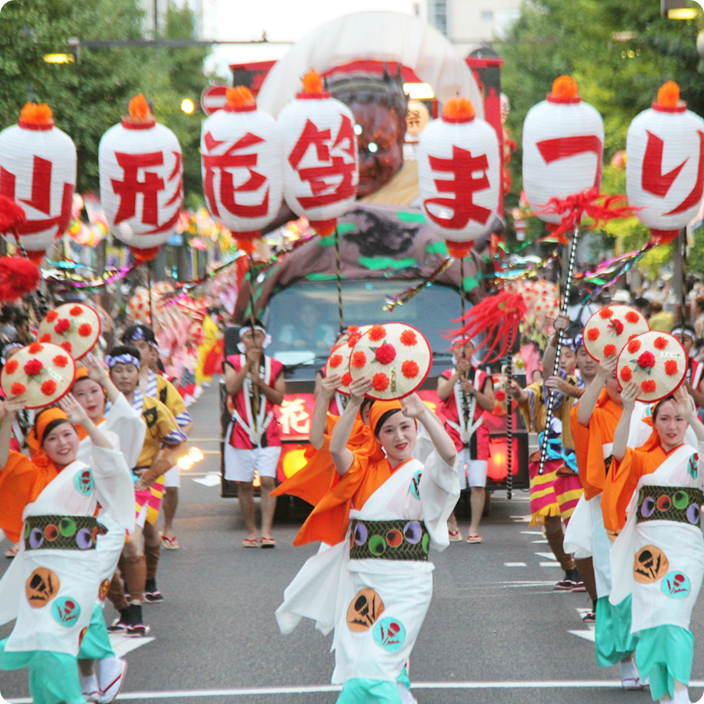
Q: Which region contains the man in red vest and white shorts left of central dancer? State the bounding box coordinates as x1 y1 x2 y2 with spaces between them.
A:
223 321 286 548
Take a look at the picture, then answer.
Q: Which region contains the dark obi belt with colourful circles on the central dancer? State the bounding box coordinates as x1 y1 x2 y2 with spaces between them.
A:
350 519 430 562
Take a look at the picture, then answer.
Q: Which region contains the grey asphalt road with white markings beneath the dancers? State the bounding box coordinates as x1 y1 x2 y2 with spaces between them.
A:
0 382 704 704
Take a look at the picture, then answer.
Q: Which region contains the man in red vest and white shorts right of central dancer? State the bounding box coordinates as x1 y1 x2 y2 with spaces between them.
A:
438 343 494 543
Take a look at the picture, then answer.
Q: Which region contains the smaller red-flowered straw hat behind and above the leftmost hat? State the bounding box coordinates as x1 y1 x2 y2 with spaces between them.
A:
37 303 100 359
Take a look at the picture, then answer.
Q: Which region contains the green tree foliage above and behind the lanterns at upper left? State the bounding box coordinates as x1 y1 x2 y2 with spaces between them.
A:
0 0 207 194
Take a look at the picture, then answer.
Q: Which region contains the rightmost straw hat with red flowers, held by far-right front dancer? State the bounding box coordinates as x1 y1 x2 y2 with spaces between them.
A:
616 330 687 403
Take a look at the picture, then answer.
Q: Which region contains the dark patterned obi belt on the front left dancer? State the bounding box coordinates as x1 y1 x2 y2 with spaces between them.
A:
24 516 107 550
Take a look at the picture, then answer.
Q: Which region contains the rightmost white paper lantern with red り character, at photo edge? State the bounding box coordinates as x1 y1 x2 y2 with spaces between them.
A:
626 81 704 242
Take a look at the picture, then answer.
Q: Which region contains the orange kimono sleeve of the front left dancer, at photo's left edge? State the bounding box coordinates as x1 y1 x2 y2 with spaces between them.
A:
0 452 47 543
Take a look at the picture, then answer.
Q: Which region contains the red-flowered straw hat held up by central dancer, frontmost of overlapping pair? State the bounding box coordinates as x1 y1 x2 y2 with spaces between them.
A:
349 323 433 401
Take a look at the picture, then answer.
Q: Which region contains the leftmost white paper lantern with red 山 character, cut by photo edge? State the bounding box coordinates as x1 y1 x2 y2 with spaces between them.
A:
0 103 76 259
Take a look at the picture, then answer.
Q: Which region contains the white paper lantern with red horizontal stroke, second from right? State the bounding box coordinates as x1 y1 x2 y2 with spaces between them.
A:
523 76 604 225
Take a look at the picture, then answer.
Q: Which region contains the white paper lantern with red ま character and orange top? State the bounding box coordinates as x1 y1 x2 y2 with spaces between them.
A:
418 98 501 257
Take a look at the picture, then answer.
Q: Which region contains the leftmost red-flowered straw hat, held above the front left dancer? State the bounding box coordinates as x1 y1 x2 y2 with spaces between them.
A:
0 342 76 409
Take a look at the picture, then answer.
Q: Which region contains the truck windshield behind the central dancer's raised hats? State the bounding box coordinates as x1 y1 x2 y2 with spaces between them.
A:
264 279 462 363
